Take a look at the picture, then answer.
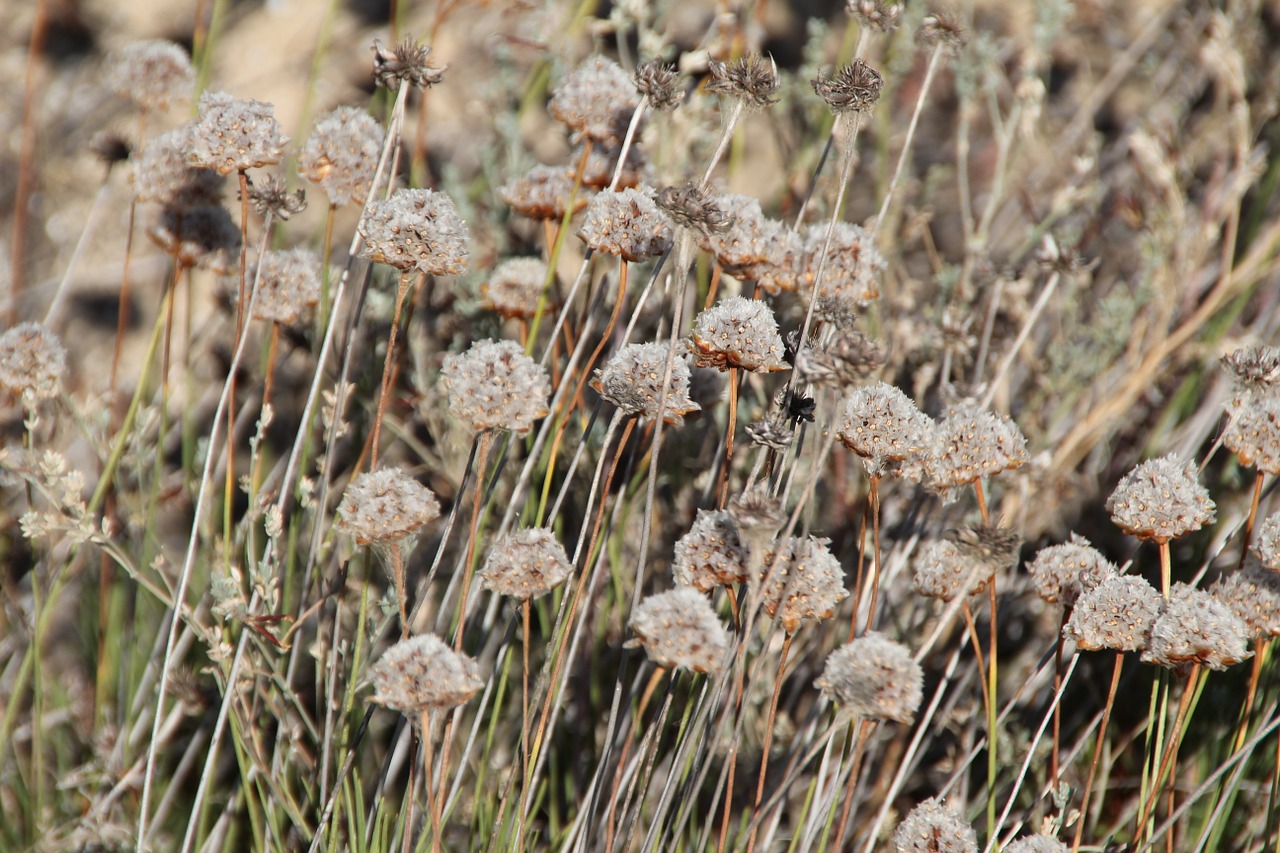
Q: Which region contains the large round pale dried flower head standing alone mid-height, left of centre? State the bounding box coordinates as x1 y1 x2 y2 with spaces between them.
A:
440 339 552 434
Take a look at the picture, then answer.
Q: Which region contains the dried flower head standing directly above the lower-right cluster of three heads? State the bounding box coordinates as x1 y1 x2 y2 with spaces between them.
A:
1107 456 1215 542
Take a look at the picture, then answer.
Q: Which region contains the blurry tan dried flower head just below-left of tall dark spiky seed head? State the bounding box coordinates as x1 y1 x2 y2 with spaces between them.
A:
298 106 385 207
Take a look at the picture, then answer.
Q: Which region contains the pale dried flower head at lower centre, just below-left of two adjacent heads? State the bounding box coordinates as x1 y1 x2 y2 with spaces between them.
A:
627 587 728 672
